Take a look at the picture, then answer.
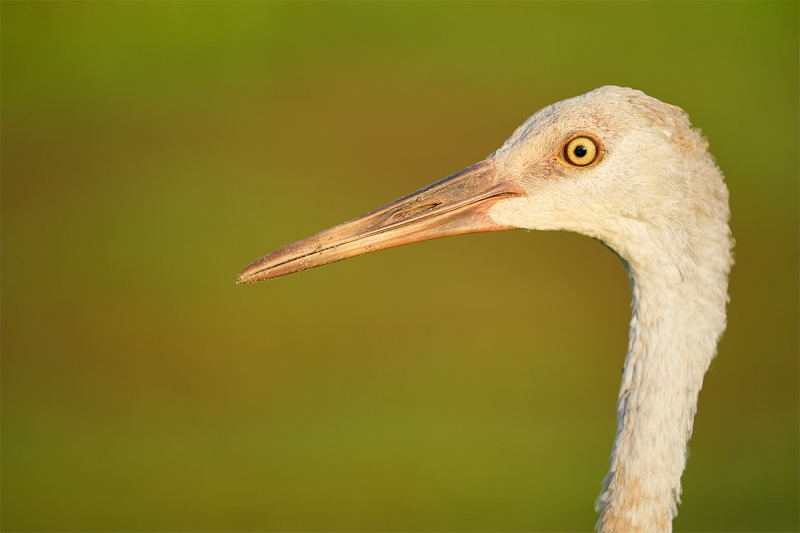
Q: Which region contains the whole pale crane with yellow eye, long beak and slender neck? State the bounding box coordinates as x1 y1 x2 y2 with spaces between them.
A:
238 87 733 532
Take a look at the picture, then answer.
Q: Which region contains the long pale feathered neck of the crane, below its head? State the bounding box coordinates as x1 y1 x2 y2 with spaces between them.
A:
597 224 732 533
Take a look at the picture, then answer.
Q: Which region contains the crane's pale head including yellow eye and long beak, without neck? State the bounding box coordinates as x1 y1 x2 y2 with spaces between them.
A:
237 86 728 283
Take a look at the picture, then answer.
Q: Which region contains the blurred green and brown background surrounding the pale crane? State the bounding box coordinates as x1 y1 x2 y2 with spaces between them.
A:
0 2 800 531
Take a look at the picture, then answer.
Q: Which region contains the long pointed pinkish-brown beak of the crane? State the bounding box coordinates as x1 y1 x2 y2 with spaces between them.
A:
236 158 524 283
